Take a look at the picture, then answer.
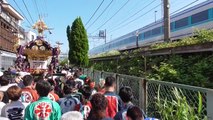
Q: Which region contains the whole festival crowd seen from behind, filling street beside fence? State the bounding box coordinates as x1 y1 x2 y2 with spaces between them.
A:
0 68 157 120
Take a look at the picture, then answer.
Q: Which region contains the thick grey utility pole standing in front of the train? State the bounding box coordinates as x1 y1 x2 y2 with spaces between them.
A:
163 0 170 42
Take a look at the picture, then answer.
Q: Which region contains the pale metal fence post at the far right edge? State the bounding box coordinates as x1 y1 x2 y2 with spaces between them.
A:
206 90 213 120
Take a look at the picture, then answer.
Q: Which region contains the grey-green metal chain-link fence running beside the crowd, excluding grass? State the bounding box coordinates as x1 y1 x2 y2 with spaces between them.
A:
84 69 213 120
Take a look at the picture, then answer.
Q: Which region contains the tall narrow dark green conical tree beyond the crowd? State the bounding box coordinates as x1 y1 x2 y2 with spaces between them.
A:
67 17 89 66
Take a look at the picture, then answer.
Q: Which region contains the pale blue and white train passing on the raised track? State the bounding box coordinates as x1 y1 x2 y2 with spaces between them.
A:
89 0 213 55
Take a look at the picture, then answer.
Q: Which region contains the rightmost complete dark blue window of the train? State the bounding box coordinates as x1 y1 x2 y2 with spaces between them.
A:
192 10 208 24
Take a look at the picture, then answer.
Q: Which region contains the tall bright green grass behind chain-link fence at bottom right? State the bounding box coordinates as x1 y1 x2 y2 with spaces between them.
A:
156 87 207 120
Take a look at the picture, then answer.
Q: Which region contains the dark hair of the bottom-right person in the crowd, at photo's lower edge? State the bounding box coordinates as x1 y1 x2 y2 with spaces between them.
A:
126 106 144 120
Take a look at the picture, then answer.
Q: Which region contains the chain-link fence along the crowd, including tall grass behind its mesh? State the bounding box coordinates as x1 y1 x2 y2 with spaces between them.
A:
84 69 213 120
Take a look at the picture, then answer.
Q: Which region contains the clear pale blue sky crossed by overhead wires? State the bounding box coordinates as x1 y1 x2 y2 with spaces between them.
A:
7 0 205 52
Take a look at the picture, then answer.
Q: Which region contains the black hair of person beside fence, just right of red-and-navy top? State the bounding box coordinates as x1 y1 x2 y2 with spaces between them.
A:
119 86 133 103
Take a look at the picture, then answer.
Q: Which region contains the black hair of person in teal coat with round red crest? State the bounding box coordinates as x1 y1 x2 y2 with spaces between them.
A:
35 80 51 97
